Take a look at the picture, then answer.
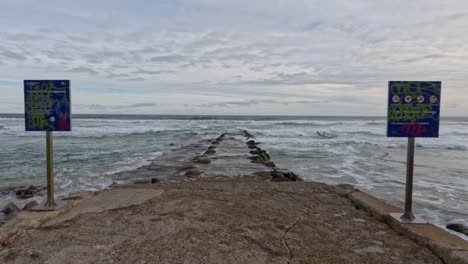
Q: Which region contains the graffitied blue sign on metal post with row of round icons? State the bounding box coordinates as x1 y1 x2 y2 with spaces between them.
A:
387 81 442 224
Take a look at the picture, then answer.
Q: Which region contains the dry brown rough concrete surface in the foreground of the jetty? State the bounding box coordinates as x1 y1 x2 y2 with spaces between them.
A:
0 178 442 263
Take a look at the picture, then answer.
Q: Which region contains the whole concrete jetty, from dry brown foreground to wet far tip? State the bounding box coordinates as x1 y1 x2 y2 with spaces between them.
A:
0 132 468 264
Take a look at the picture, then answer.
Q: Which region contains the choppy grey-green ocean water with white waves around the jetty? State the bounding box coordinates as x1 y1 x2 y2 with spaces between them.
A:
0 115 468 236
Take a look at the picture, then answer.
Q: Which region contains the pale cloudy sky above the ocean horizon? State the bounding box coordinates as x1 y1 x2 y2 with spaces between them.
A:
0 0 468 116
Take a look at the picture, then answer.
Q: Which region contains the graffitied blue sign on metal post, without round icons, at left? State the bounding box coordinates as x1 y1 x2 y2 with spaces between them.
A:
24 80 71 211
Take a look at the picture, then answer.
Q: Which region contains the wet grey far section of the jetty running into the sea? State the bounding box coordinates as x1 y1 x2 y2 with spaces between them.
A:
110 133 278 183
